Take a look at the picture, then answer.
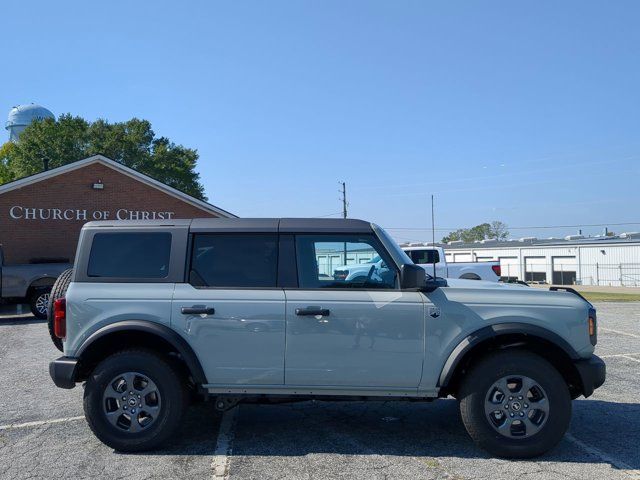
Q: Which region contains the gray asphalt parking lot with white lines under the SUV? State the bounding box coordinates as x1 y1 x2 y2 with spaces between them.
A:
0 302 640 480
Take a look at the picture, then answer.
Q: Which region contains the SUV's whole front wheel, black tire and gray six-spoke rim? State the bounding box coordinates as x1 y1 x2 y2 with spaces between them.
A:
459 350 571 458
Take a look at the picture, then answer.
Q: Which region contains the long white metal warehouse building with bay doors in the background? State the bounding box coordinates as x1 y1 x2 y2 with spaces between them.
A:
442 232 640 287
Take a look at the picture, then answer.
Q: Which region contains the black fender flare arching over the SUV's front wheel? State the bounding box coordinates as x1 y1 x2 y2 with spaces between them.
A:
438 322 580 387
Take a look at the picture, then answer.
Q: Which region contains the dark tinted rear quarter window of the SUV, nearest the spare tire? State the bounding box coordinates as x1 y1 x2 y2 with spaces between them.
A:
87 233 171 278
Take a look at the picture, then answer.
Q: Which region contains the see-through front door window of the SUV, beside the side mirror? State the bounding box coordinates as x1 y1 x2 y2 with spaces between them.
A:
296 235 397 289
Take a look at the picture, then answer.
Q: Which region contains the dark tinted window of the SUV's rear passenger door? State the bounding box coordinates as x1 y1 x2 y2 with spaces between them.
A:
189 234 278 287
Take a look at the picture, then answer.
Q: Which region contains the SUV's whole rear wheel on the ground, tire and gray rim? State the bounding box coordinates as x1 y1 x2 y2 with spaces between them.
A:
84 350 187 452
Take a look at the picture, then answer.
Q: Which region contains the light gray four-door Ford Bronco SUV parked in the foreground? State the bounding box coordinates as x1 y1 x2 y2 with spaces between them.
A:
50 218 605 457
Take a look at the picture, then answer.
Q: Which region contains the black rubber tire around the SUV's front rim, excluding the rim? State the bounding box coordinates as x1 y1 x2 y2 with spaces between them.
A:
458 350 571 458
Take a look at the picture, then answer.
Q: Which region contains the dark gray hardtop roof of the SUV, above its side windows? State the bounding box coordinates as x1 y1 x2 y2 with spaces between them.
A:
84 218 371 233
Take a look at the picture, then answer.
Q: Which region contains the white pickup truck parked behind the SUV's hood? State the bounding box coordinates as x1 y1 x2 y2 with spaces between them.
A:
401 246 501 282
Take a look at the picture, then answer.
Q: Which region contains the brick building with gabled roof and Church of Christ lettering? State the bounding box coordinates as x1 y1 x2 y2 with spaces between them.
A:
0 155 235 263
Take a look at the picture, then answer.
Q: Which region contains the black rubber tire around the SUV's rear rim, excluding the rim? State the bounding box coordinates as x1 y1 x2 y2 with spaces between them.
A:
84 350 188 452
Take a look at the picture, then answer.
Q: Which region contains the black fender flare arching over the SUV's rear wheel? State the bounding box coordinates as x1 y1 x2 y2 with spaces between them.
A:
75 320 207 385
